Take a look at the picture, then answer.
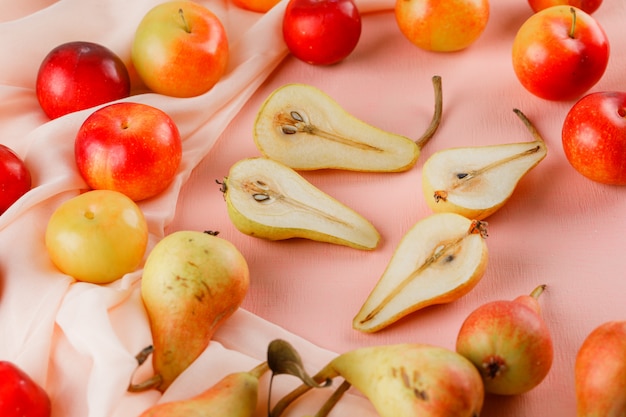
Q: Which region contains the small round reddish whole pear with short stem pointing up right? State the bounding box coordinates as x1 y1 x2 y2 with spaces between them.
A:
456 285 554 395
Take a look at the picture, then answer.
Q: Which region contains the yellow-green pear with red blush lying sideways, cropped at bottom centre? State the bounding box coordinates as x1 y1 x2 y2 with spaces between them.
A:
271 343 485 417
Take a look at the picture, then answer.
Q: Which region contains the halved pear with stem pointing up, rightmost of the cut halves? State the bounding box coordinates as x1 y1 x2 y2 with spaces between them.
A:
422 109 548 220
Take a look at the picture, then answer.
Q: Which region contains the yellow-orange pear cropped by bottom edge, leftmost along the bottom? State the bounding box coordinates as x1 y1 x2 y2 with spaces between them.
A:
139 362 269 417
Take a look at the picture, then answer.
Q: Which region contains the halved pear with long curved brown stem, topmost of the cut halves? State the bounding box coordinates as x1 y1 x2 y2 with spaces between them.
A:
254 76 442 172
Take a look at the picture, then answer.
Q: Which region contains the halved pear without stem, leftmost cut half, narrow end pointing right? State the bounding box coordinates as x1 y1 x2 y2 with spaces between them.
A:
222 157 380 250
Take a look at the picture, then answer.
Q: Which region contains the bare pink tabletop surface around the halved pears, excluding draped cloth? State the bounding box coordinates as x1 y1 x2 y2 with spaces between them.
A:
170 1 626 416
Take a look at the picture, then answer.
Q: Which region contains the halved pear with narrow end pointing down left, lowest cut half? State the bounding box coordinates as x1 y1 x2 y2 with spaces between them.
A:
352 213 488 332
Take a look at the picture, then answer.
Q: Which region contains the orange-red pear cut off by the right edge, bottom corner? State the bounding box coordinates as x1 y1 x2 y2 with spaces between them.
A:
574 321 626 417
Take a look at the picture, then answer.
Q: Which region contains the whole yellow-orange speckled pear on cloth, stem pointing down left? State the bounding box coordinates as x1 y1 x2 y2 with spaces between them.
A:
129 231 249 392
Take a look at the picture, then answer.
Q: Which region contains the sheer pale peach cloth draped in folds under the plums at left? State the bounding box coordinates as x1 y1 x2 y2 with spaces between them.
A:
0 0 391 417
